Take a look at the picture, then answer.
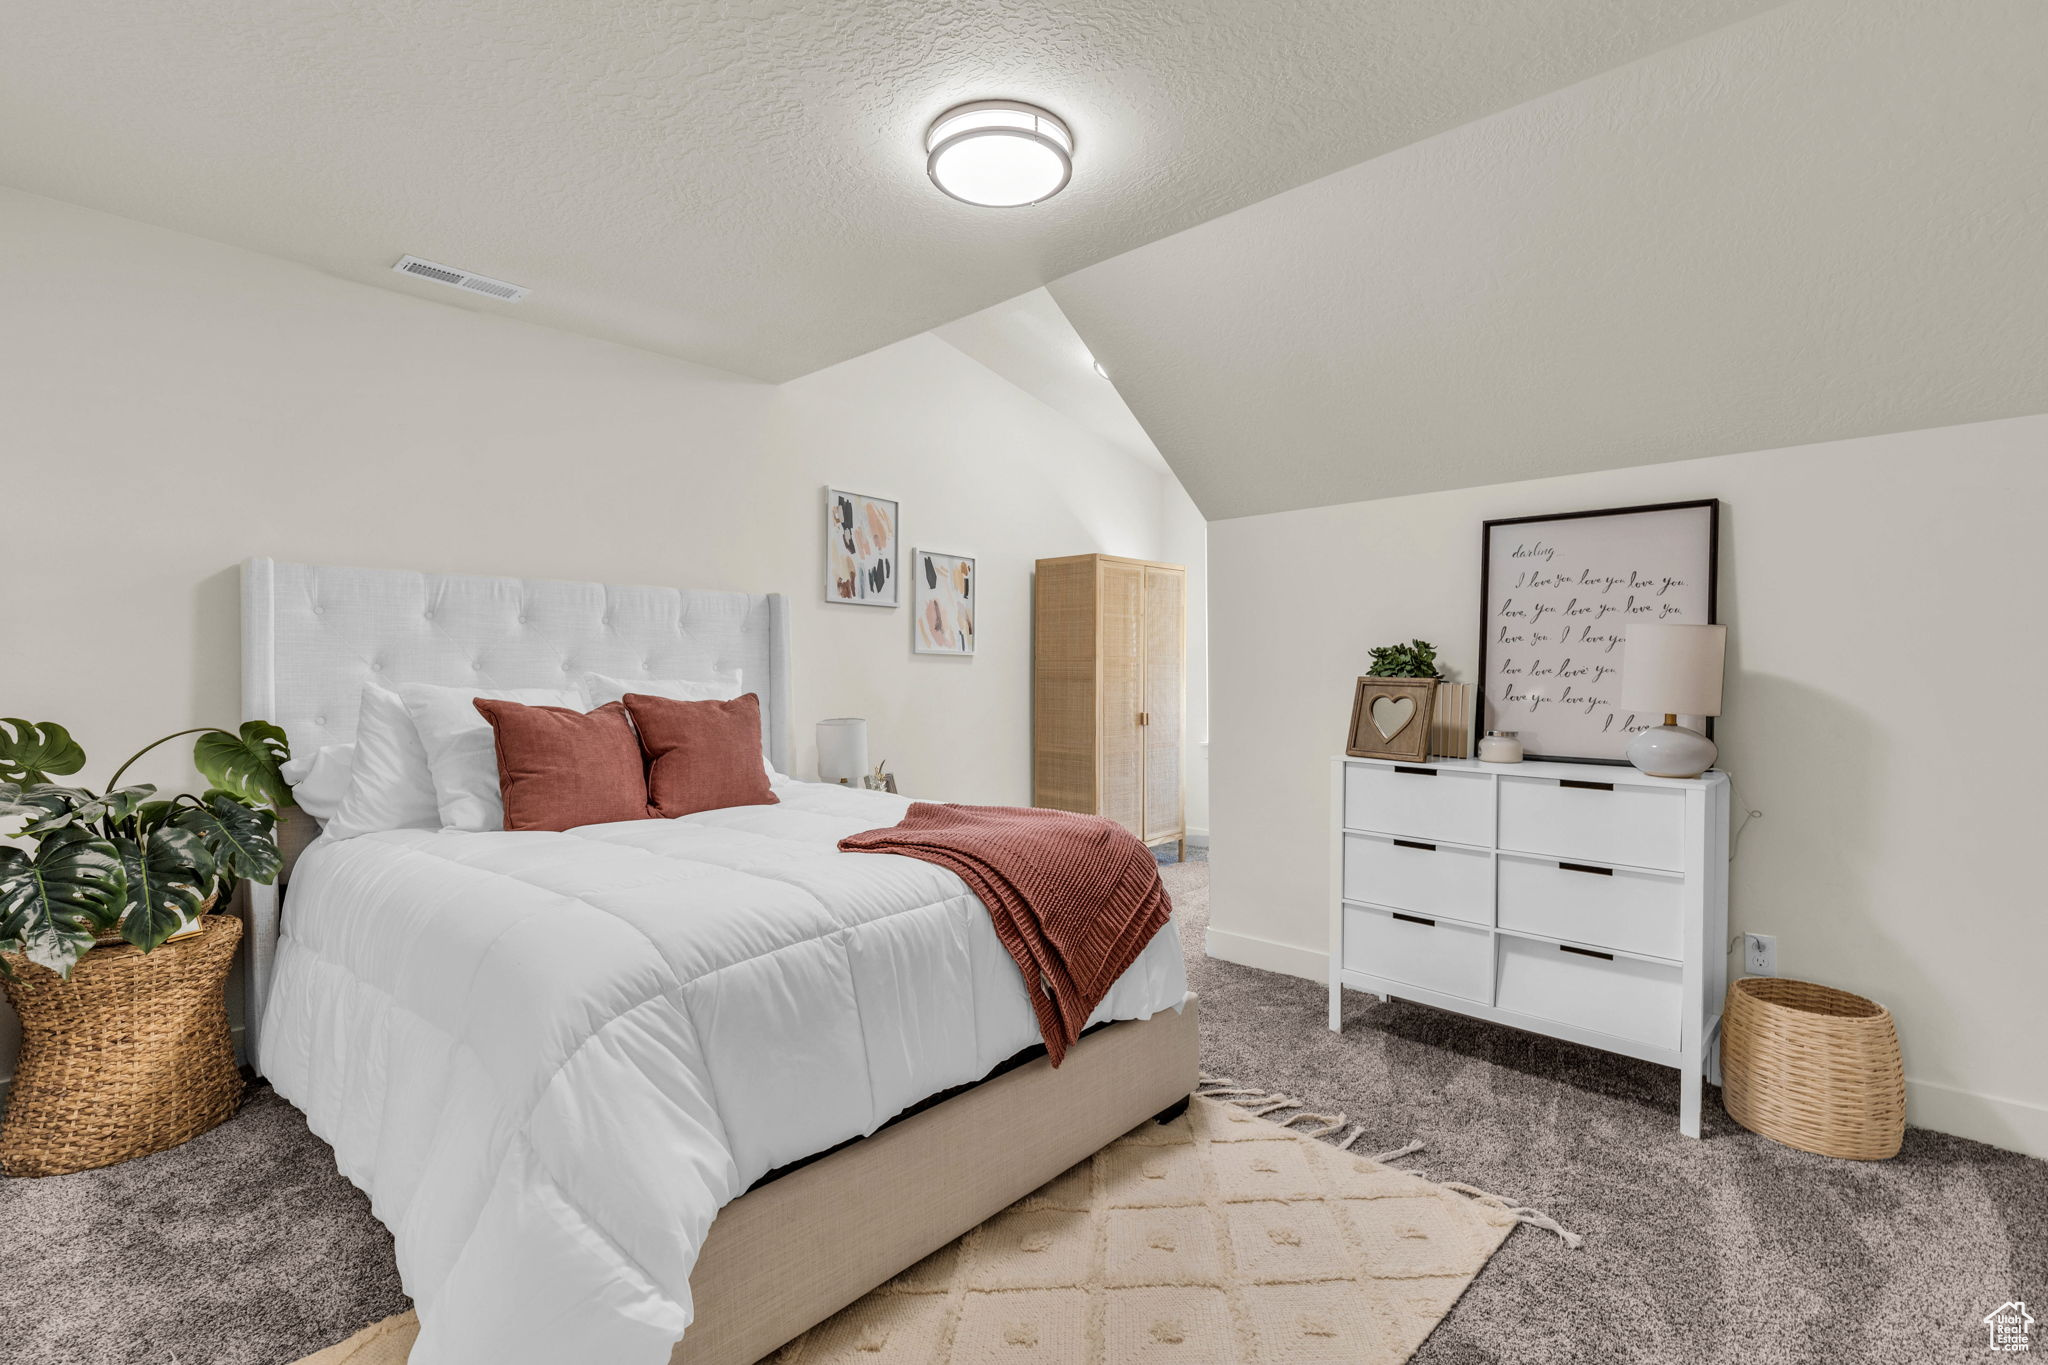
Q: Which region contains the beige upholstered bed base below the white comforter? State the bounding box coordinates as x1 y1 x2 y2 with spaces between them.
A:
670 995 1196 1365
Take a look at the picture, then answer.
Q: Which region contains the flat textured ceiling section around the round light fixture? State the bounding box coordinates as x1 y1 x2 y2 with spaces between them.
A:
0 0 1767 379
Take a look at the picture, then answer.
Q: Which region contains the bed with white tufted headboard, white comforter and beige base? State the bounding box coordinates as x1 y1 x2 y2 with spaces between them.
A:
244 559 1196 1365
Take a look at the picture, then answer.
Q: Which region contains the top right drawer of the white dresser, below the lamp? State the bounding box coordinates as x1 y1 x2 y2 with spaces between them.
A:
1501 769 1686 872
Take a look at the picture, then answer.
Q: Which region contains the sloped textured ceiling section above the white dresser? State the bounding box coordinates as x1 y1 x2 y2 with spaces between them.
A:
1051 0 2048 520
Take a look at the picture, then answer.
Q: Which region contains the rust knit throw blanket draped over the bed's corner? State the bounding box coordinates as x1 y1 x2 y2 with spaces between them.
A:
840 800 1174 1066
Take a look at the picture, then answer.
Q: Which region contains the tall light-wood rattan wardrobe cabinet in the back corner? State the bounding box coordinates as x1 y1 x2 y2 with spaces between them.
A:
1032 555 1188 855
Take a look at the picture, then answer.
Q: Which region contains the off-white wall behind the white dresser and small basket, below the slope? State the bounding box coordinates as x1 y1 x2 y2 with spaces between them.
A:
1208 415 2048 1156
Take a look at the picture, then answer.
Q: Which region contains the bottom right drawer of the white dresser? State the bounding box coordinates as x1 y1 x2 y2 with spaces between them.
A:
1495 933 1679 1048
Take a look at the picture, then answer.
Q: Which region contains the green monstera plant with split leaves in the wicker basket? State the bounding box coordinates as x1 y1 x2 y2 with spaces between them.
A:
0 718 293 976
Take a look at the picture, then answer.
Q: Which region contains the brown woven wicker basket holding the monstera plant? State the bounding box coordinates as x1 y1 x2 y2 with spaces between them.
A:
0 915 242 1175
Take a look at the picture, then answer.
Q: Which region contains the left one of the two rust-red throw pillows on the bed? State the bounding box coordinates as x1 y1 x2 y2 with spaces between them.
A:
475 698 651 829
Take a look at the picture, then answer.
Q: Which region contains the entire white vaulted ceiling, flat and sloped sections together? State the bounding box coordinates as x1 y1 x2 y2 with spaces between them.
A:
12 0 2048 518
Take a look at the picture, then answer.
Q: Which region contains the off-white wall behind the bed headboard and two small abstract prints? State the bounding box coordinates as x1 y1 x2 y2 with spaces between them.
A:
0 190 1184 1076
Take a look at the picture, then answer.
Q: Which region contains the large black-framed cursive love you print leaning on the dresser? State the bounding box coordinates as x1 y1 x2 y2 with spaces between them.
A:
1475 497 1720 763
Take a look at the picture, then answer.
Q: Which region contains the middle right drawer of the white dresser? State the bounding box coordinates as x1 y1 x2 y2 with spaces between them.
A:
1497 853 1686 960
